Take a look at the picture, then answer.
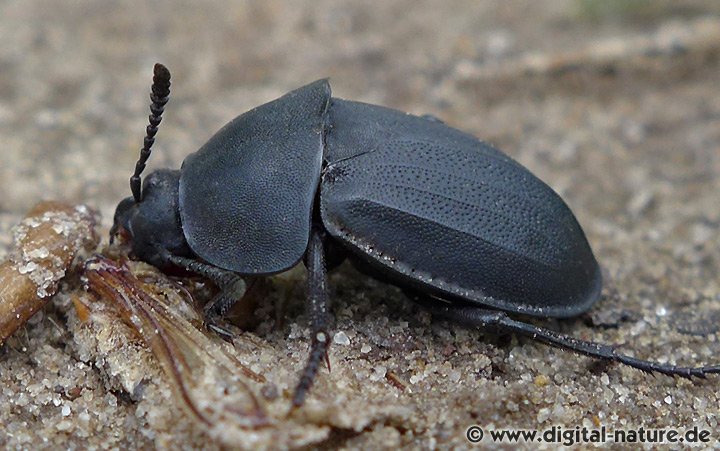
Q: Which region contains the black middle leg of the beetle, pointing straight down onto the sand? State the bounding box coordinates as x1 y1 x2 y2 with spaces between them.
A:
292 230 330 408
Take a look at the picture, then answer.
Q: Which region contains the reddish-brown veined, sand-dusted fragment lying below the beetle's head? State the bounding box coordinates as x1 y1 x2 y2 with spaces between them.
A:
85 256 268 428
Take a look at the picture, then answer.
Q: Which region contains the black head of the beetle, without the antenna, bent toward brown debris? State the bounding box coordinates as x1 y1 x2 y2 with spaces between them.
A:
110 169 191 267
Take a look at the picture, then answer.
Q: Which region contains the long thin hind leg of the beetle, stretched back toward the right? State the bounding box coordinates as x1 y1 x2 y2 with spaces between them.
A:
415 297 720 379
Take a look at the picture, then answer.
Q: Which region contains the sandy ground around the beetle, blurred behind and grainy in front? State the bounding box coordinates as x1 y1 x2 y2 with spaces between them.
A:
0 0 720 449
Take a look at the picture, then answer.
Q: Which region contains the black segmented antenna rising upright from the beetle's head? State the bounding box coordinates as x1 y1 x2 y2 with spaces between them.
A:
130 63 170 202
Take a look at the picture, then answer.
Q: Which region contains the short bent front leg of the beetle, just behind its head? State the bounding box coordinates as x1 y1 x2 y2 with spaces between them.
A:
159 250 246 341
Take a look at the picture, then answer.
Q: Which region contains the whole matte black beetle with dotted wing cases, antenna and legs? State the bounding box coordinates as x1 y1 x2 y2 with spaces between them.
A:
111 64 720 406
